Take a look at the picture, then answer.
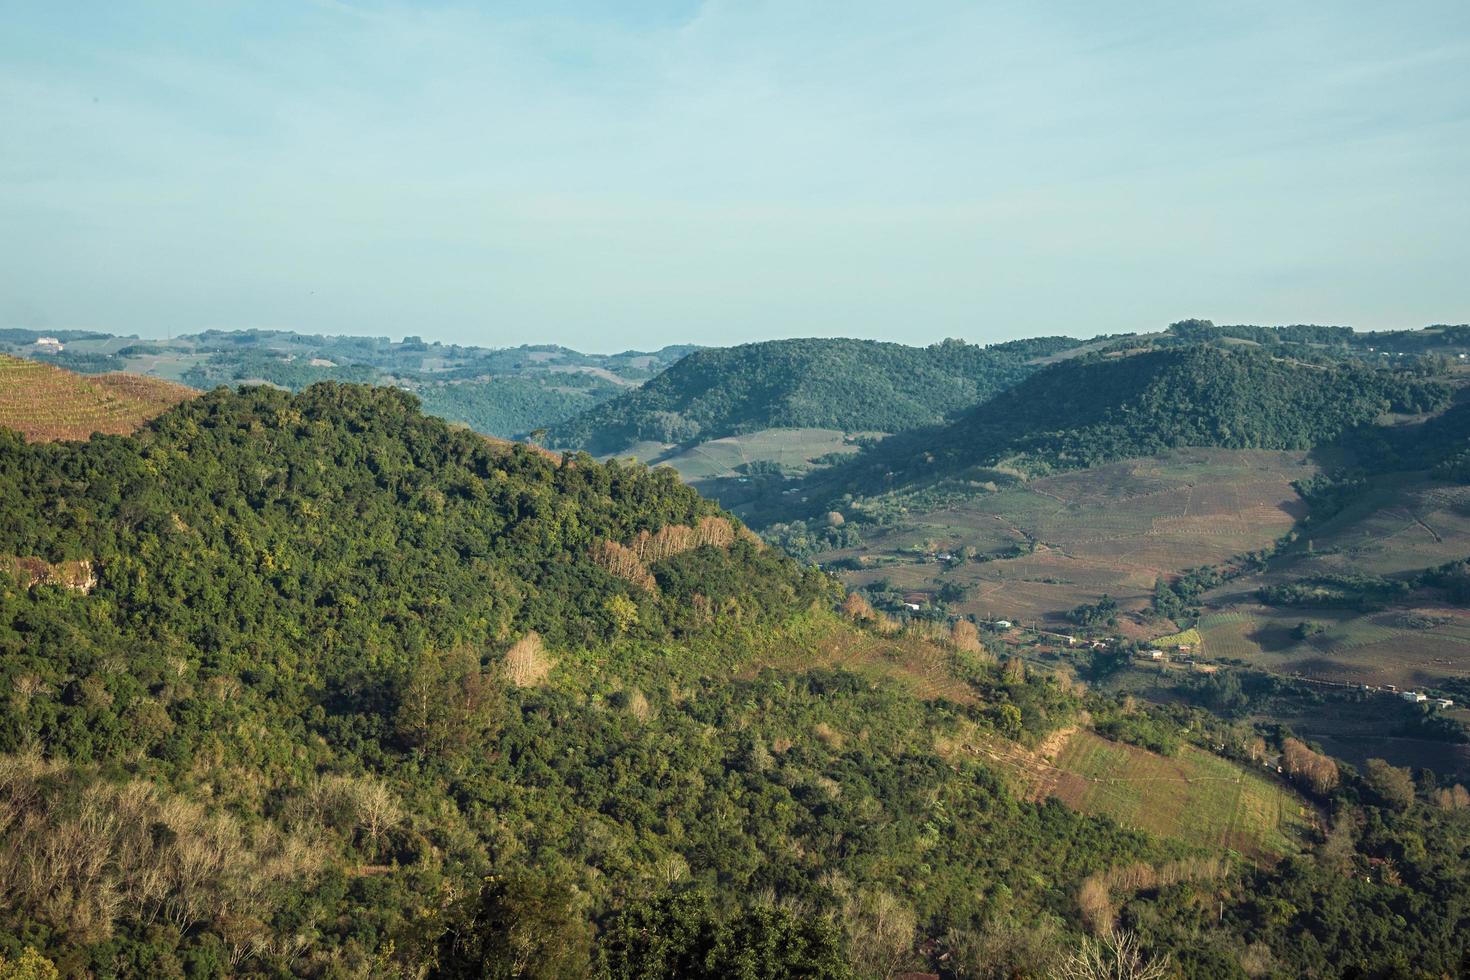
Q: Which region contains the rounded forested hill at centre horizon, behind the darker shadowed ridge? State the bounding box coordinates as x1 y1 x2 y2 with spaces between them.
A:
548 338 1079 454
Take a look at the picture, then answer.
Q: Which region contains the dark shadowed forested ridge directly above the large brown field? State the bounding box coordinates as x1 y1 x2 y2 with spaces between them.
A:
793 344 1449 511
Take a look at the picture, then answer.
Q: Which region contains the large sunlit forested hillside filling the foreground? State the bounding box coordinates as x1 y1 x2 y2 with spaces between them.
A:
0 383 1470 980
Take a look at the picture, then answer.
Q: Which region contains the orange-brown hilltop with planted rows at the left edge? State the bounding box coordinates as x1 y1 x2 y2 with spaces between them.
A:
0 354 198 442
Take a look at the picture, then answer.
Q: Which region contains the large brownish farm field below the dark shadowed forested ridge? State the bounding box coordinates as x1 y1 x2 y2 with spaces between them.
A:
819 450 1316 624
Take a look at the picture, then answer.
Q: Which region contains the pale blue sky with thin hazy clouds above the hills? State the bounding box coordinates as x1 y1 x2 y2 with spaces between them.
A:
0 0 1470 351
